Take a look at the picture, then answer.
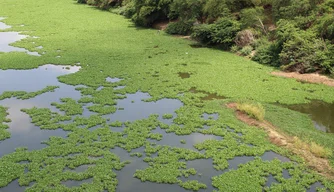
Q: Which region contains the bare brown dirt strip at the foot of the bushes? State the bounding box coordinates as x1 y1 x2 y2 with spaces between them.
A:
271 71 334 87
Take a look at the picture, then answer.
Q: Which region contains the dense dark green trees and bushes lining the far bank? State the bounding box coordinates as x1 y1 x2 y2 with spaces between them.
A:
78 0 334 75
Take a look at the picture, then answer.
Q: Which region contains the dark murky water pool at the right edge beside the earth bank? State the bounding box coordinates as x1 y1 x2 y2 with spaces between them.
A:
286 100 334 133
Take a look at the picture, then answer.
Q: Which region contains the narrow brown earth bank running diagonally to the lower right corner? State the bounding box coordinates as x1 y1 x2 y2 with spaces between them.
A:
226 103 334 180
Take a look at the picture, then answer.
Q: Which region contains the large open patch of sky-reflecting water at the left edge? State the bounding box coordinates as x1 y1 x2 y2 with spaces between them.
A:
0 65 80 157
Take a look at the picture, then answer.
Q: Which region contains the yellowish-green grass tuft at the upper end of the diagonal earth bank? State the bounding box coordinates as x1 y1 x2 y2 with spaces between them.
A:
237 102 265 121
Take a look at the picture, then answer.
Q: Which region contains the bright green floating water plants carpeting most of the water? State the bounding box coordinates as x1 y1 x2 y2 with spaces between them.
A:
0 0 334 191
